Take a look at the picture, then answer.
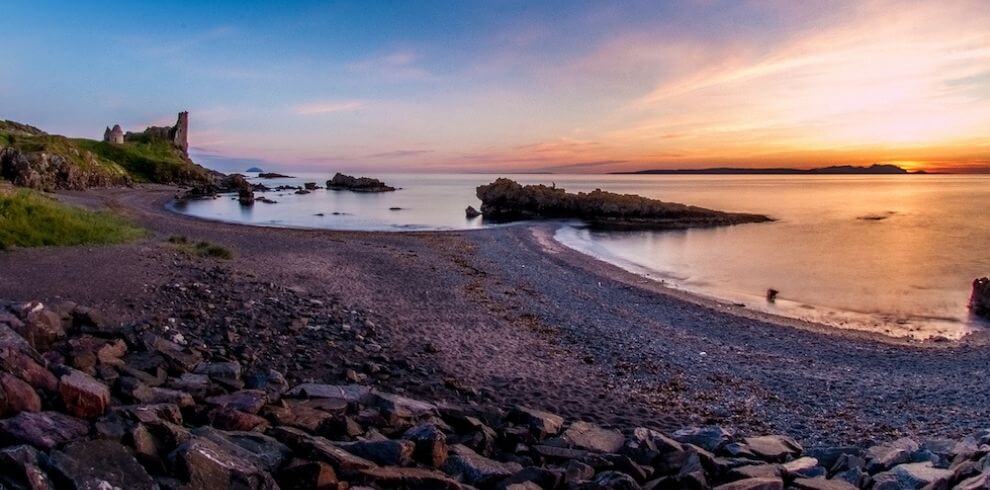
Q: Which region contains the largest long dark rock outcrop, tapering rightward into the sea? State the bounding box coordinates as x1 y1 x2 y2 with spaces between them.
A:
477 178 771 229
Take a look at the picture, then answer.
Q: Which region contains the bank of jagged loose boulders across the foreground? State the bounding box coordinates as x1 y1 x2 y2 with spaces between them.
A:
0 302 990 489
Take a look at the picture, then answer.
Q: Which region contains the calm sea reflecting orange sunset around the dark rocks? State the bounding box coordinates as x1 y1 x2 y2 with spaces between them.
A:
172 174 990 338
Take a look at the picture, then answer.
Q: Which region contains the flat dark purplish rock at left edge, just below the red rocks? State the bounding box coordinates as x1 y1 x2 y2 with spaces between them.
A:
0 412 89 450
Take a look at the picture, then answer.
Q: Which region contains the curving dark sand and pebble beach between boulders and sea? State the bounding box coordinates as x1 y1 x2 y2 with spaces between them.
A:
0 186 990 444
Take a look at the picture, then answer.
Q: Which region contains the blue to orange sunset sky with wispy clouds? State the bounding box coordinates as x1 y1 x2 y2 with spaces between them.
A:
0 0 990 173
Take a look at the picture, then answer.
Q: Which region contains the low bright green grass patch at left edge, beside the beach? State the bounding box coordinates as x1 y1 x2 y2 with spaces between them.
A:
0 189 145 250
